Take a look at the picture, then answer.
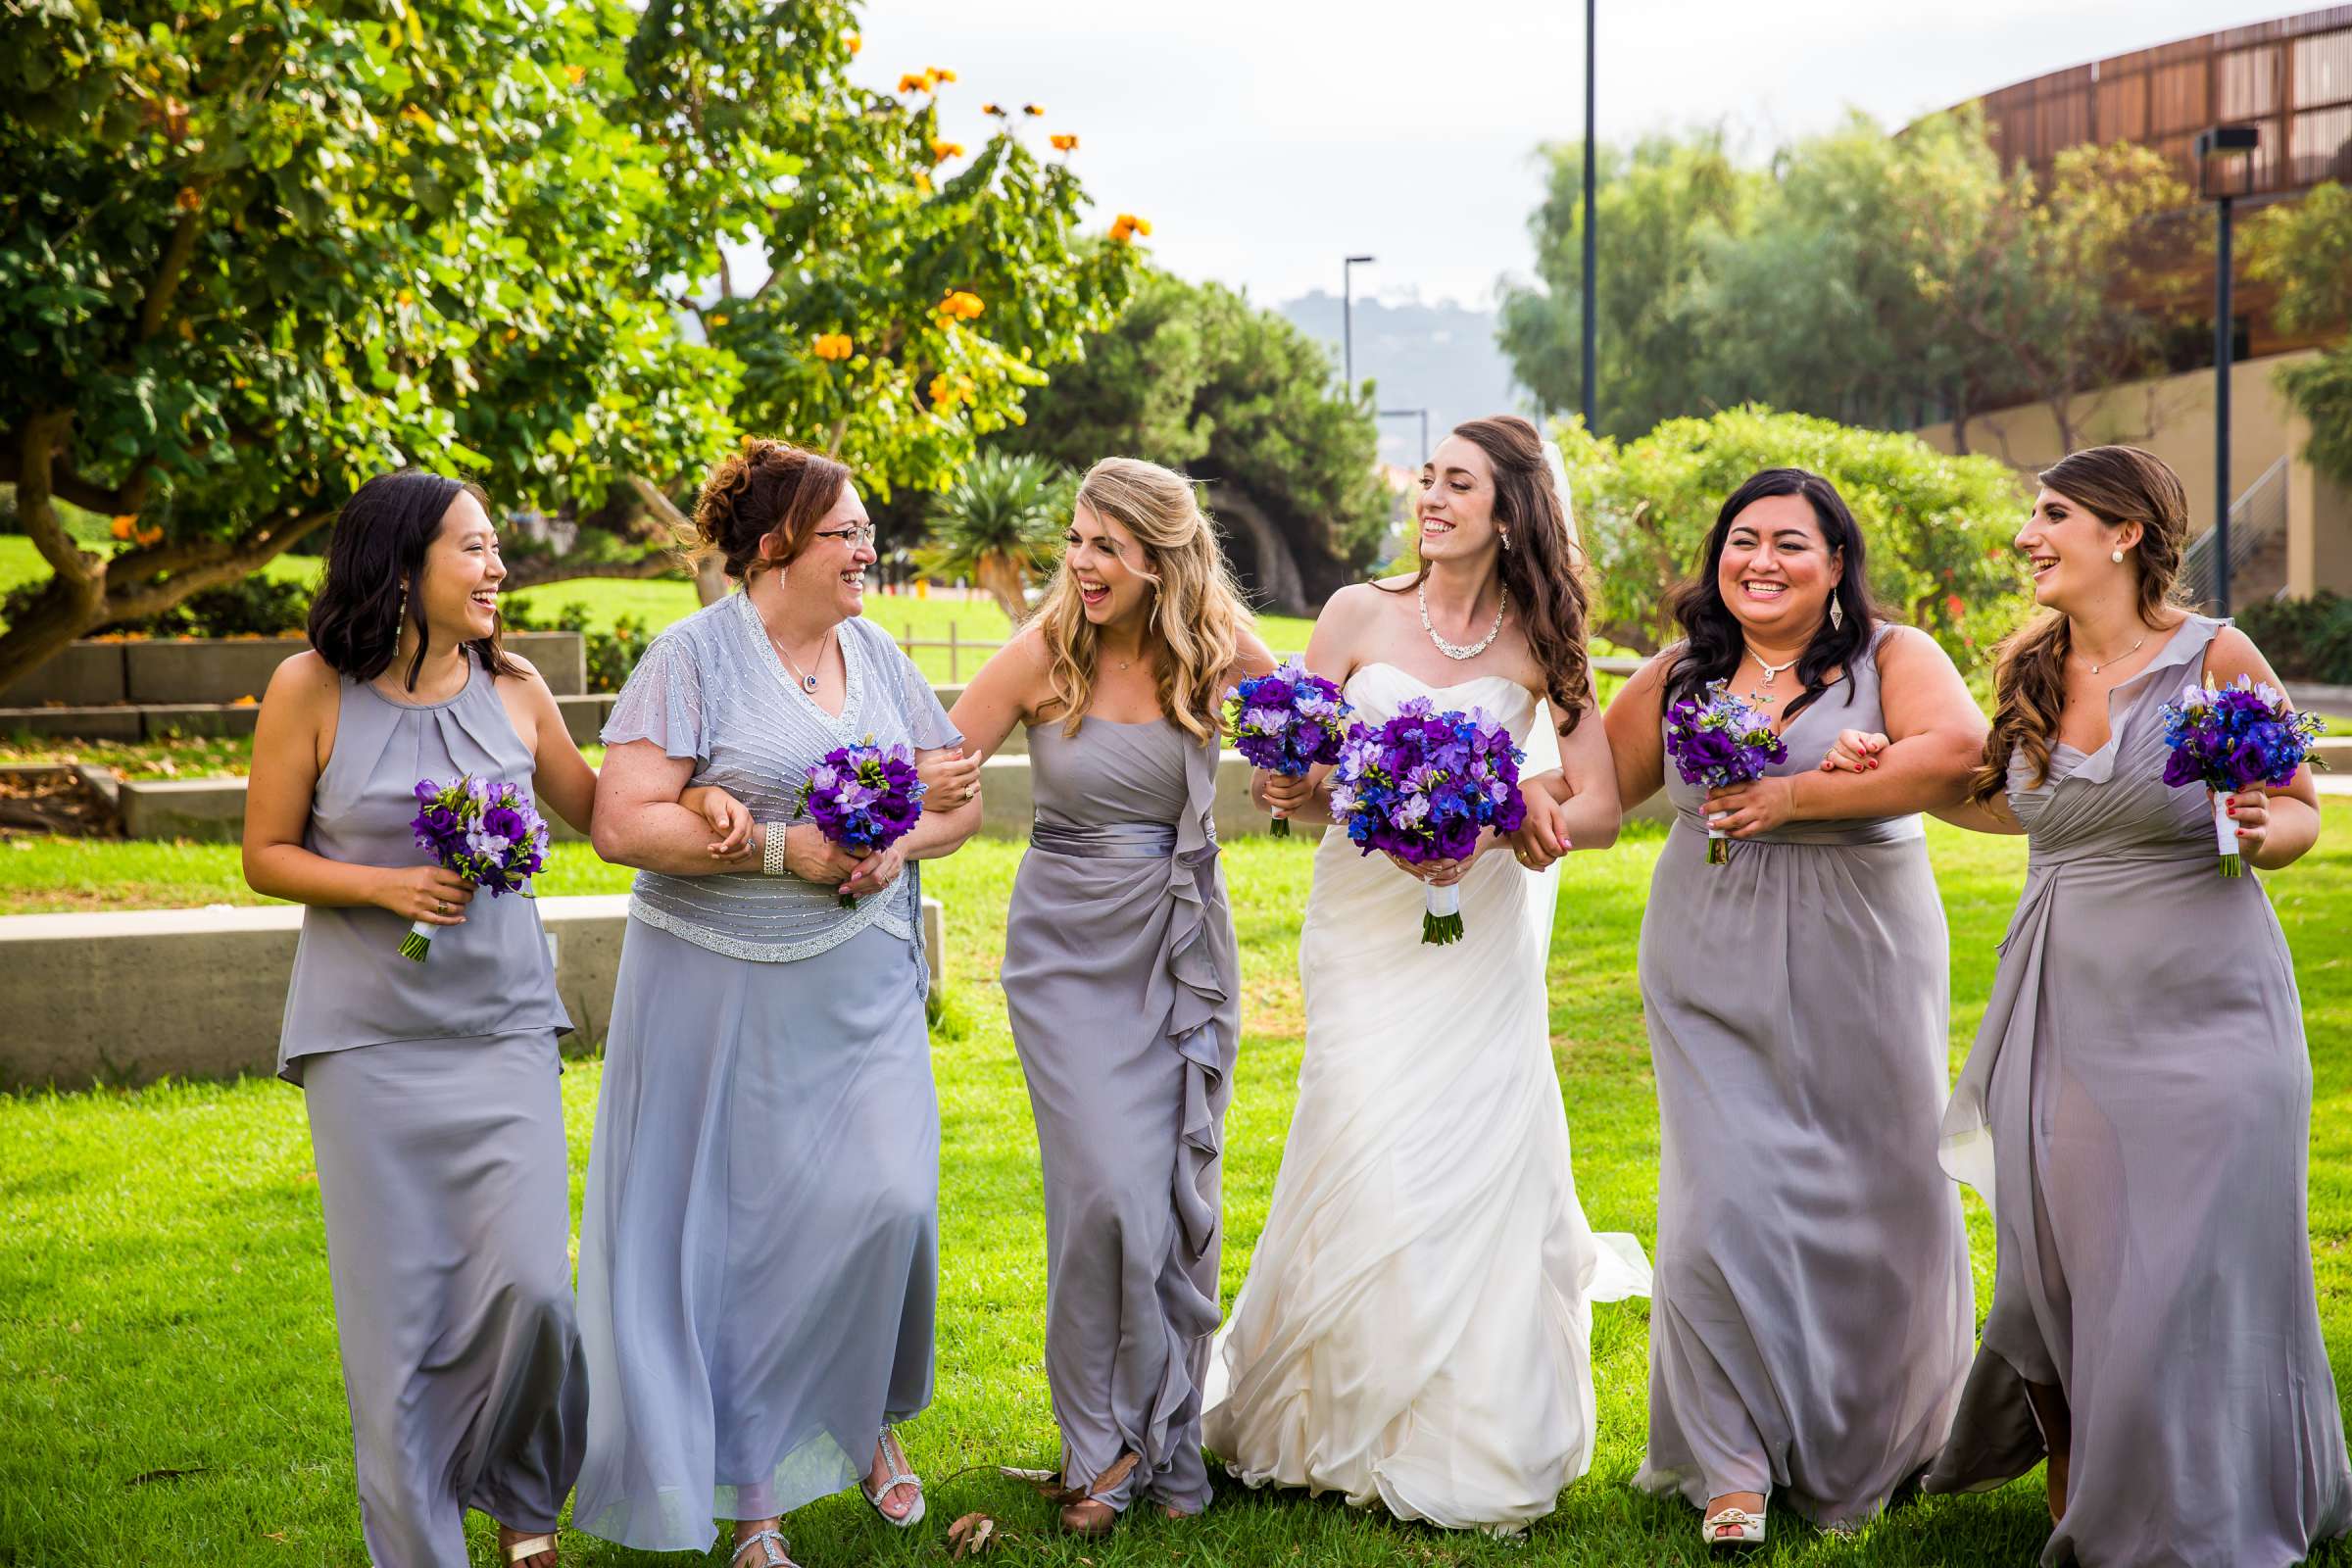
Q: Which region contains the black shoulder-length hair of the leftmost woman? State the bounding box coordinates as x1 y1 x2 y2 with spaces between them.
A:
308 467 522 691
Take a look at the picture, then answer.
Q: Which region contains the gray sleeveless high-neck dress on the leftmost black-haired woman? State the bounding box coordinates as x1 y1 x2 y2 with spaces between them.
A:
277 665 588 1568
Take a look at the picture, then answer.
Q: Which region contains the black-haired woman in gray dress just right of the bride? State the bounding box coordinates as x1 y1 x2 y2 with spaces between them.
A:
1606 467 1985 1546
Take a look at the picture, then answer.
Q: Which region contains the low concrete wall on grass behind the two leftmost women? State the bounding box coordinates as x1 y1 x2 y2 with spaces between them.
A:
0 894 946 1089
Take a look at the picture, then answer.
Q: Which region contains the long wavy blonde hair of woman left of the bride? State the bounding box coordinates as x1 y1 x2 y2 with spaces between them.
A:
1035 459 1249 745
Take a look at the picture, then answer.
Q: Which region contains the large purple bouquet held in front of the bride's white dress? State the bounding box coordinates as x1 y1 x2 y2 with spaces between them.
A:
1331 696 1527 943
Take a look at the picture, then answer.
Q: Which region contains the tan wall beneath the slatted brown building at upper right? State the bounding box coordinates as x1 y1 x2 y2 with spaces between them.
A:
1917 350 2352 595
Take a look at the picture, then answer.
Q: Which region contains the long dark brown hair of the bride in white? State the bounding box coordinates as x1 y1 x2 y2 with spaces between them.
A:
1374 414 1592 736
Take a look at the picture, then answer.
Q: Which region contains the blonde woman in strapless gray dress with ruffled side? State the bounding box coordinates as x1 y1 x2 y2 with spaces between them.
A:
955 459 1272 1535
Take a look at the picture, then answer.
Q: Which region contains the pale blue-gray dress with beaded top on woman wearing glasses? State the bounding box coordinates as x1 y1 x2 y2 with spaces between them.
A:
571 592 957 1551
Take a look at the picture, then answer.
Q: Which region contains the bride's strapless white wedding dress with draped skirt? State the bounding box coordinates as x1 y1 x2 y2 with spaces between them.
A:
1204 662 1648 1531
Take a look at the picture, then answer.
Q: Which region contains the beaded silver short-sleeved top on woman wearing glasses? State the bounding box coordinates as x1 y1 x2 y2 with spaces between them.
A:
605 590 962 964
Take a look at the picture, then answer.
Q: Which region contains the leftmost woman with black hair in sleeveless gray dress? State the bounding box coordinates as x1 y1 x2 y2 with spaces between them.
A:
245 470 748 1568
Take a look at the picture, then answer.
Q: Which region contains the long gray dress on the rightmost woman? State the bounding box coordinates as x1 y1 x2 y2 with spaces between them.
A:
1927 615 2352 1568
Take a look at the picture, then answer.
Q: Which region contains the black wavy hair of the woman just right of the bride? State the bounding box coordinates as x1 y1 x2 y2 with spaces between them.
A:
1665 467 1880 724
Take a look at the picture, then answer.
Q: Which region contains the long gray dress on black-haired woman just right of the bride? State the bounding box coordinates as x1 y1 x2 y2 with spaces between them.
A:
1637 630 1976 1526
